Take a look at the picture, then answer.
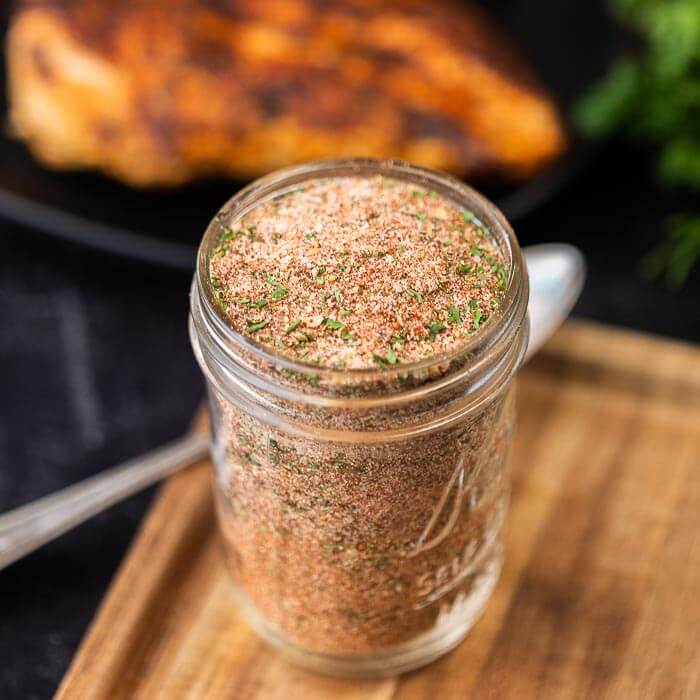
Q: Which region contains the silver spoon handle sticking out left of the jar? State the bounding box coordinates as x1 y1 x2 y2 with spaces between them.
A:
0 433 209 569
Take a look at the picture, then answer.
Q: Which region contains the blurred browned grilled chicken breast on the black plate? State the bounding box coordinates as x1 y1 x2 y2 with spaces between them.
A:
7 0 565 186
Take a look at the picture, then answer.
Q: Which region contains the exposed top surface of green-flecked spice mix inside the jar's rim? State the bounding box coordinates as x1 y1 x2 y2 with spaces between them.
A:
211 177 507 368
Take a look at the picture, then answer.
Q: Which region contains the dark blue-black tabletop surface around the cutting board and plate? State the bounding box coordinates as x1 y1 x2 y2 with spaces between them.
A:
0 147 700 699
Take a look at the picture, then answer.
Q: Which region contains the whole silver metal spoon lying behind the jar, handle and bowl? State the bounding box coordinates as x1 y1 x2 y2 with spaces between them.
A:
0 243 586 569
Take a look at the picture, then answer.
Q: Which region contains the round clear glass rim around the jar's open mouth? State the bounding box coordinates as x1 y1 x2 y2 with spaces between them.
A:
195 158 528 384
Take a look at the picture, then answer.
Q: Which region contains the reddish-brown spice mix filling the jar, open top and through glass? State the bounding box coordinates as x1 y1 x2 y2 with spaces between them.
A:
205 177 513 655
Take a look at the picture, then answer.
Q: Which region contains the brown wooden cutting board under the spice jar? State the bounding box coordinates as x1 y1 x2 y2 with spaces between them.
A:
58 323 700 700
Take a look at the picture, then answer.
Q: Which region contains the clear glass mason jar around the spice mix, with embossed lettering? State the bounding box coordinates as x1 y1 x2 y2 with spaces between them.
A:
190 159 528 677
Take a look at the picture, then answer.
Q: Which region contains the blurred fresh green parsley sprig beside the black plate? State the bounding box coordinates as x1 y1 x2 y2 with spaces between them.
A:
574 0 700 287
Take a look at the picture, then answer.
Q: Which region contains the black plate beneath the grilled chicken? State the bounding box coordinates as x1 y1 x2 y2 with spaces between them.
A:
0 0 614 268
